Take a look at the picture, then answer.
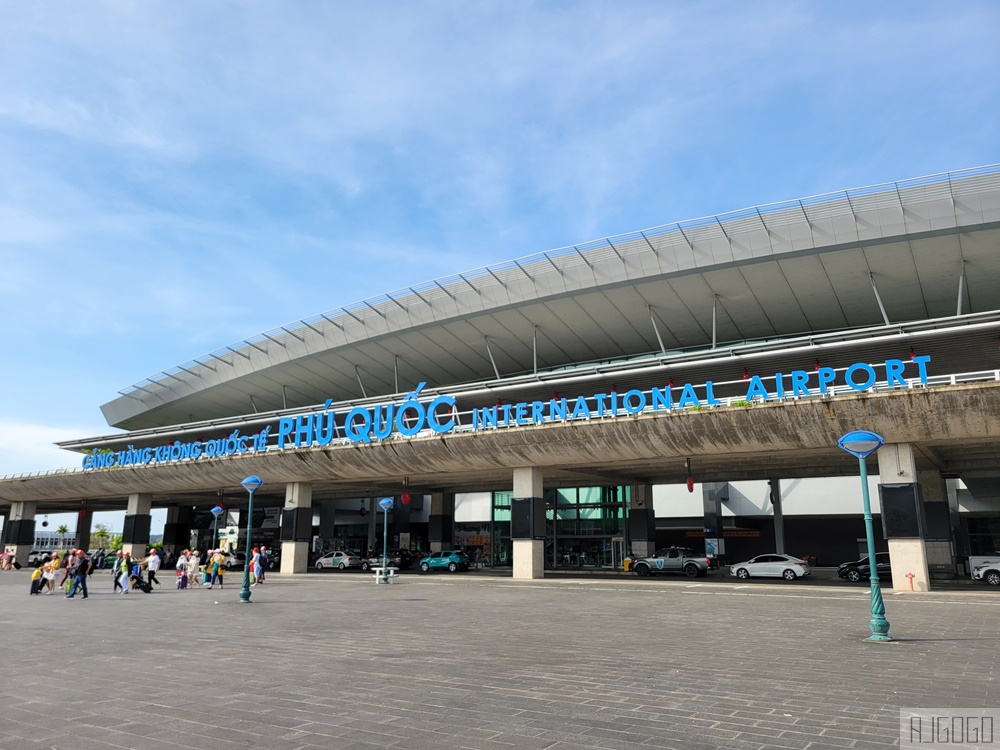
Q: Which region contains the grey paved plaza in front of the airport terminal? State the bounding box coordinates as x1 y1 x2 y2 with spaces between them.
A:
0 571 1000 750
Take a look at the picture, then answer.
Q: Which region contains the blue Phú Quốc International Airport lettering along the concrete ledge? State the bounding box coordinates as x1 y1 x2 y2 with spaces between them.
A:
83 356 931 469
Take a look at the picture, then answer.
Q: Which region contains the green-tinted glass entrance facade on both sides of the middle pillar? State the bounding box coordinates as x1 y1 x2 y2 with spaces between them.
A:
490 487 631 569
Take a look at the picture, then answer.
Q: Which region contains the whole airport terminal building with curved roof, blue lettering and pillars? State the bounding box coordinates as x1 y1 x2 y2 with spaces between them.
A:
0 166 1000 590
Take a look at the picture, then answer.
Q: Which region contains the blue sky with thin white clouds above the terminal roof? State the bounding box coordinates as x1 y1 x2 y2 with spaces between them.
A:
0 0 1000 500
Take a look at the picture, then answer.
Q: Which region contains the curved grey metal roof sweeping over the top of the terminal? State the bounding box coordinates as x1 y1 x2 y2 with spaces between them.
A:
101 165 1000 429
